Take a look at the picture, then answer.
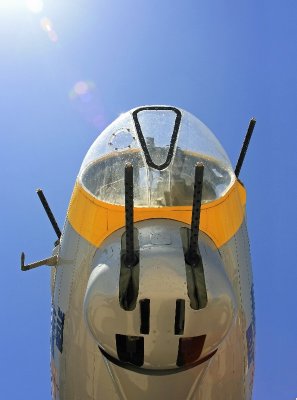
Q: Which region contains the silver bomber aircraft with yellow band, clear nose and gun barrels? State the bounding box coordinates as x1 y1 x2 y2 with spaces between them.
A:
21 106 255 400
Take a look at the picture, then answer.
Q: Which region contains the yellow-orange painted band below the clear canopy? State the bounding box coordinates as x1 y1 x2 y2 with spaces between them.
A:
68 181 246 247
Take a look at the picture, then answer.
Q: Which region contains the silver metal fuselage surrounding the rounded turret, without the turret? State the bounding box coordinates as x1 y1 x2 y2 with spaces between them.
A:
51 219 255 400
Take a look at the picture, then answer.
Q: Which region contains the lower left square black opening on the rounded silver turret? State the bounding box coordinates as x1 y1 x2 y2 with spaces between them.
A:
116 334 144 367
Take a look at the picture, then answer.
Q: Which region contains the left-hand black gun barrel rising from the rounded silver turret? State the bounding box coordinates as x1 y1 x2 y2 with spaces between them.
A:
125 163 138 267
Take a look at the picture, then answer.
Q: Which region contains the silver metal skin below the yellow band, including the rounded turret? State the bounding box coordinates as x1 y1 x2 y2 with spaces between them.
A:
46 107 255 400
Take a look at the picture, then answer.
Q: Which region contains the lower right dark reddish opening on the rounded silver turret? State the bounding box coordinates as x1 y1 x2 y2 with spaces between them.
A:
176 335 206 367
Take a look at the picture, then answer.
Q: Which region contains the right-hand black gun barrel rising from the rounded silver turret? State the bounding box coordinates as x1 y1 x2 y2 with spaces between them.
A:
186 163 204 265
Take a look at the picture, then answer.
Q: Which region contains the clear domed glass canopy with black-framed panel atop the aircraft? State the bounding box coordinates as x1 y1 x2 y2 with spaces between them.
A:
78 106 235 207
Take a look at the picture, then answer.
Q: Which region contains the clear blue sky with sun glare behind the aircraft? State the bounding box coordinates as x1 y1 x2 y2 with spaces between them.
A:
0 0 297 400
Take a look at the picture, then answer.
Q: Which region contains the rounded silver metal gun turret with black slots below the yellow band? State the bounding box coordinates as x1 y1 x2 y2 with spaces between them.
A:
84 220 236 370
